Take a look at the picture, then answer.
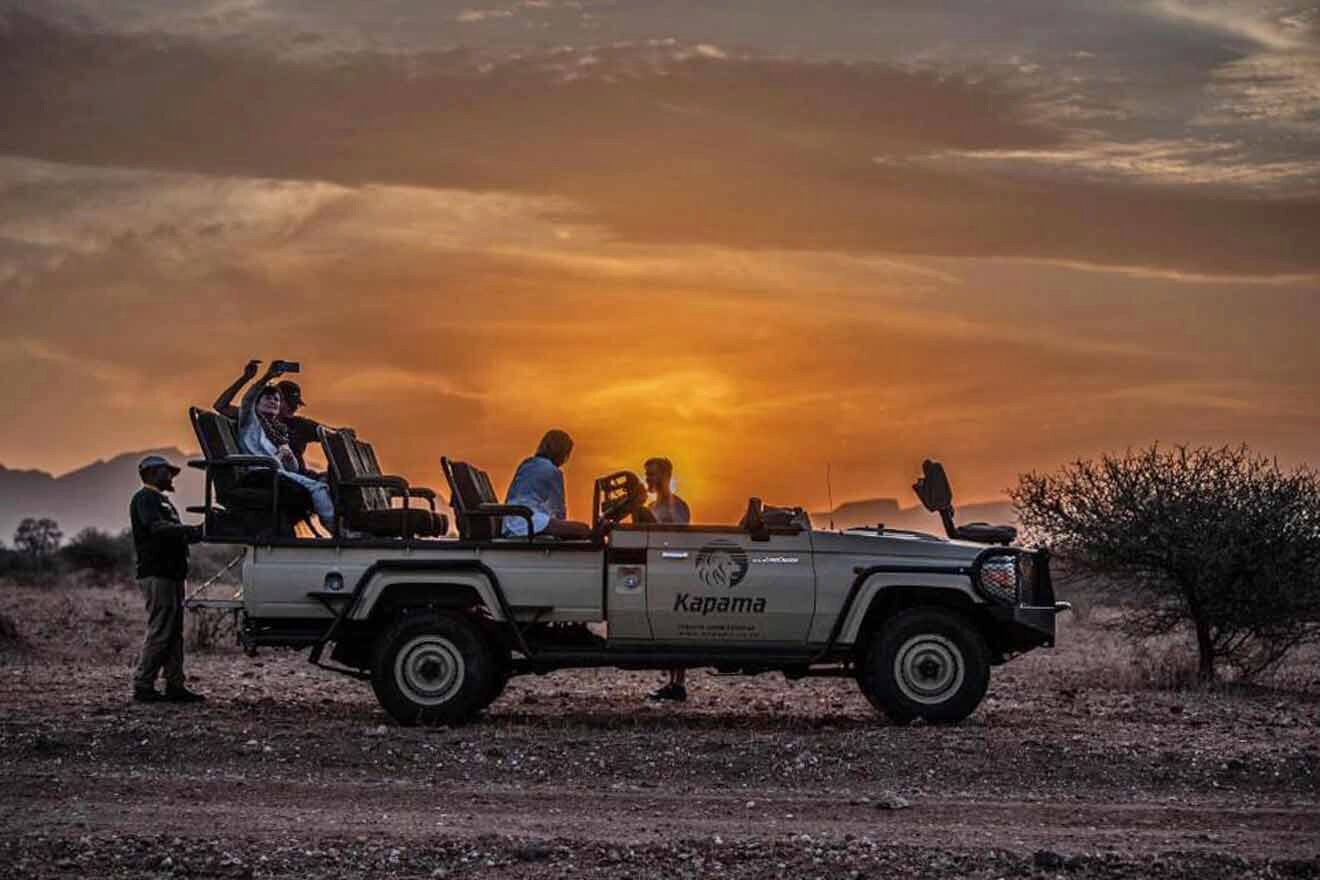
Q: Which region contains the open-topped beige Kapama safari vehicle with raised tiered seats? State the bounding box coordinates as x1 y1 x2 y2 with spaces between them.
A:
190 410 1064 724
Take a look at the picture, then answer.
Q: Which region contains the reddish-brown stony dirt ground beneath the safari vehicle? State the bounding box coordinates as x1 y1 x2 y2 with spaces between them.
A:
0 586 1320 880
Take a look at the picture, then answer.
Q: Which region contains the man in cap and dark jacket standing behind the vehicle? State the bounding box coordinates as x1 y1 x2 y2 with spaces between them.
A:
128 455 206 703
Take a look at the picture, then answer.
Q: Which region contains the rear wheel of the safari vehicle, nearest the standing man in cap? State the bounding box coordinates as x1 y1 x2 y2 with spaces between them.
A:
371 610 495 726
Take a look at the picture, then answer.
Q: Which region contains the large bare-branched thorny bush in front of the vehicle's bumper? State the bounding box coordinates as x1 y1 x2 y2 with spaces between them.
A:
1010 445 1320 681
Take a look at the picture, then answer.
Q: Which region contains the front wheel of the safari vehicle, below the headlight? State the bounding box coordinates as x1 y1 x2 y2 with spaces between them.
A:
858 607 990 724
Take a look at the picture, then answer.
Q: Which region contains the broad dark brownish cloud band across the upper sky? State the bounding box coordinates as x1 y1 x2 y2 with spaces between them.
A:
0 15 1320 274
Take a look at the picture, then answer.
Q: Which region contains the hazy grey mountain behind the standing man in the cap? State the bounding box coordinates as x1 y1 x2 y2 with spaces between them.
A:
0 449 202 545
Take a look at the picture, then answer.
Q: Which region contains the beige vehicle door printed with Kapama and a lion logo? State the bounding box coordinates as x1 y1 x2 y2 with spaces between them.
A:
647 525 816 645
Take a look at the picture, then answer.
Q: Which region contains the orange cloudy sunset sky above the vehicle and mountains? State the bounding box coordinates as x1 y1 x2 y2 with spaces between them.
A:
0 0 1320 520
